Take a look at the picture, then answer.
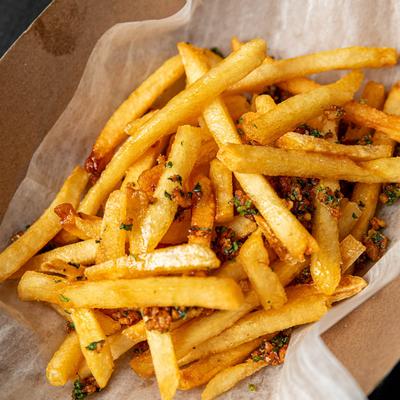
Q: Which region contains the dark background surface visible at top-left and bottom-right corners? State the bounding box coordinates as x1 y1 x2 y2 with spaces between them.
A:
0 0 400 400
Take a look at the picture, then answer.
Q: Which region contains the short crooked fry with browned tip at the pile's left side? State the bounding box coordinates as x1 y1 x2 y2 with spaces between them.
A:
54 203 101 240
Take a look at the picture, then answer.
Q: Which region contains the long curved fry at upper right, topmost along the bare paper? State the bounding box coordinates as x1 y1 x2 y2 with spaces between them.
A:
229 47 397 93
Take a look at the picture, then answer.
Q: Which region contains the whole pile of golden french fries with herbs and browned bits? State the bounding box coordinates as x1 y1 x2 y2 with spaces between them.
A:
0 37 400 400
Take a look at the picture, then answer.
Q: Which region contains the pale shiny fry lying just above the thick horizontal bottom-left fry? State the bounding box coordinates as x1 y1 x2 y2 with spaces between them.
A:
85 244 220 281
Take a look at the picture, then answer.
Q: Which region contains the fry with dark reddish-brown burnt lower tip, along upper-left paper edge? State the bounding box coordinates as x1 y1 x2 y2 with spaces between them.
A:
86 56 183 178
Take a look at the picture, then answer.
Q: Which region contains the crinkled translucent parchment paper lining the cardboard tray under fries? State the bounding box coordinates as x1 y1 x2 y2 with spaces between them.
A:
0 0 400 400
